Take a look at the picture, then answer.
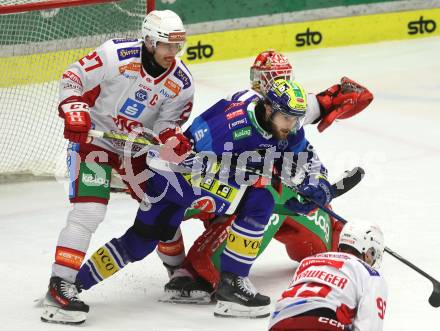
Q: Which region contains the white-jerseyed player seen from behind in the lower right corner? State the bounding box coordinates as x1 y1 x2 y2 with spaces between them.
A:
269 223 387 331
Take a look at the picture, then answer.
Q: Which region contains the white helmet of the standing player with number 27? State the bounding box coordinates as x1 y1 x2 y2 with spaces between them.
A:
142 9 186 50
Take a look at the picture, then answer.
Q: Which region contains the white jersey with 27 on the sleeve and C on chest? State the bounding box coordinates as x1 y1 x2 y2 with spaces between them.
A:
60 39 194 154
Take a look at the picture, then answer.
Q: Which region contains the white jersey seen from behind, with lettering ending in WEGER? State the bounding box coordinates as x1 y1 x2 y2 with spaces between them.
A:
270 252 387 331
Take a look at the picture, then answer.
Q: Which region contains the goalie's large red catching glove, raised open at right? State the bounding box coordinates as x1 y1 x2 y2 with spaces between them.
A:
316 77 373 132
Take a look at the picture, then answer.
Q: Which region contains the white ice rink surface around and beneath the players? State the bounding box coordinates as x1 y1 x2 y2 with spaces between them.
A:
0 38 440 331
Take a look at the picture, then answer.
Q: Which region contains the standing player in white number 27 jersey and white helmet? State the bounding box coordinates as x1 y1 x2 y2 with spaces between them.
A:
41 10 194 324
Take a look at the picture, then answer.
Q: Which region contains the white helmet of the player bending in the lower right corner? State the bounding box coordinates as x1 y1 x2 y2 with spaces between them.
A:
339 223 385 269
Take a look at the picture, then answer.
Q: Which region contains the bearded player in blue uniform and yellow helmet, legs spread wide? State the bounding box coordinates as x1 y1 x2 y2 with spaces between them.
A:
76 79 333 317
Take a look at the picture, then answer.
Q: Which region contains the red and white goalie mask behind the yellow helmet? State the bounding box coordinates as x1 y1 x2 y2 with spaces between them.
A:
250 49 293 95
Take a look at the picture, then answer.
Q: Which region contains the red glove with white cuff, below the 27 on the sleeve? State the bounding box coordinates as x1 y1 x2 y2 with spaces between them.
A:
59 101 92 143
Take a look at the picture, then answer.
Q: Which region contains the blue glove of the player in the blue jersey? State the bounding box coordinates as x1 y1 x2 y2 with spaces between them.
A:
285 175 335 215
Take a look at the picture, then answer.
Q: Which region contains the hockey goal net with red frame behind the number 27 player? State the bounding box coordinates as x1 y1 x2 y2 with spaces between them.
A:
0 0 151 182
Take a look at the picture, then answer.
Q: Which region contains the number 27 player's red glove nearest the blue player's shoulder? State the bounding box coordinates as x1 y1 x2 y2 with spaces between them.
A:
159 128 192 163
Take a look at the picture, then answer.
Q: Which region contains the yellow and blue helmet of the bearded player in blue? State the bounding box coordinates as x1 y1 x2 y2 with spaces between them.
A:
266 78 307 118
